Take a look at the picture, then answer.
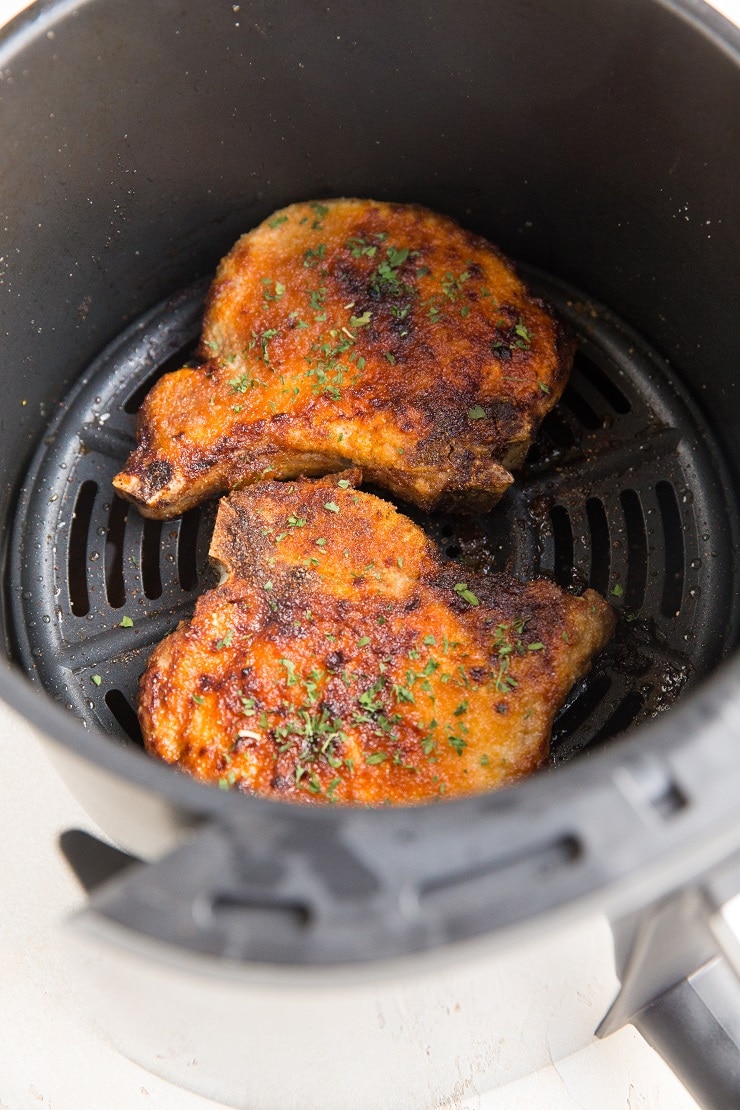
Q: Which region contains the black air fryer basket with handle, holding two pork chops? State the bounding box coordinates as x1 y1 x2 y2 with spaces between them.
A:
0 0 740 1107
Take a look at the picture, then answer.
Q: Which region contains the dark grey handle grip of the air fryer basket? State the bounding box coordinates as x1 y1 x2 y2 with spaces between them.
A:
633 956 740 1110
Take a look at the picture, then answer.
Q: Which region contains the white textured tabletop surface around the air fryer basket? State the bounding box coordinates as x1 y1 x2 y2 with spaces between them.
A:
0 0 740 1110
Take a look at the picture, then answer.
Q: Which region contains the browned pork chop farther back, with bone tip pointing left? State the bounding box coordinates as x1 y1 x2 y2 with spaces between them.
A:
114 200 574 517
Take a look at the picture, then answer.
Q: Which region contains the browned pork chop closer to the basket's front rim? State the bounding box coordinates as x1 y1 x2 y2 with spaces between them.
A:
139 472 615 805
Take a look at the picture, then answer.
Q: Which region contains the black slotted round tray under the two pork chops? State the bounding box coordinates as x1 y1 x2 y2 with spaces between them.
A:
9 274 738 761
